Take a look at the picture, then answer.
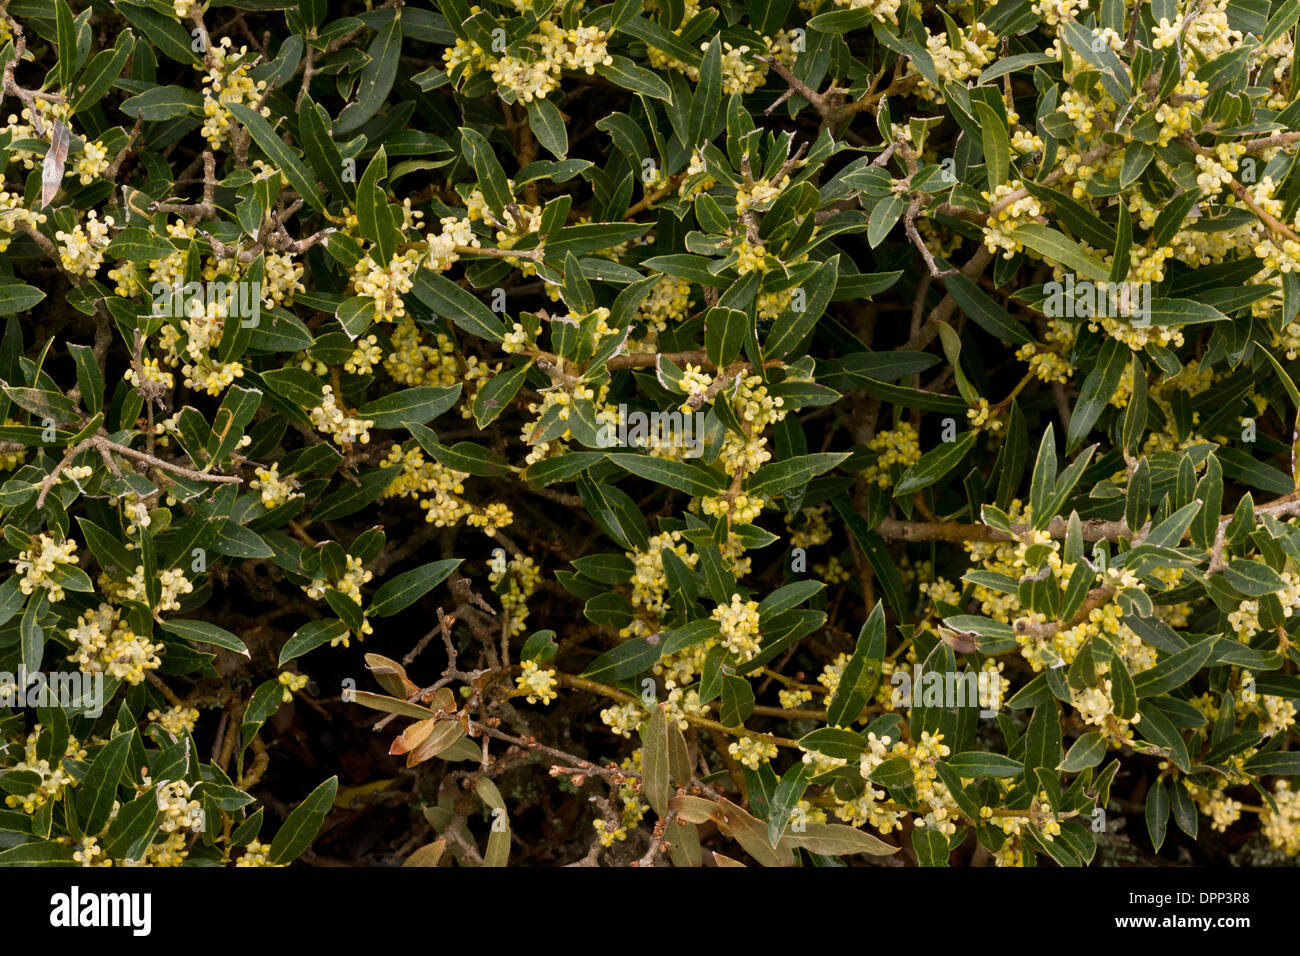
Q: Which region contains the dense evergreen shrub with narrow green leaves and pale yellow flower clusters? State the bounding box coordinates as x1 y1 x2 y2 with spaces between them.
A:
0 0 1300 866
